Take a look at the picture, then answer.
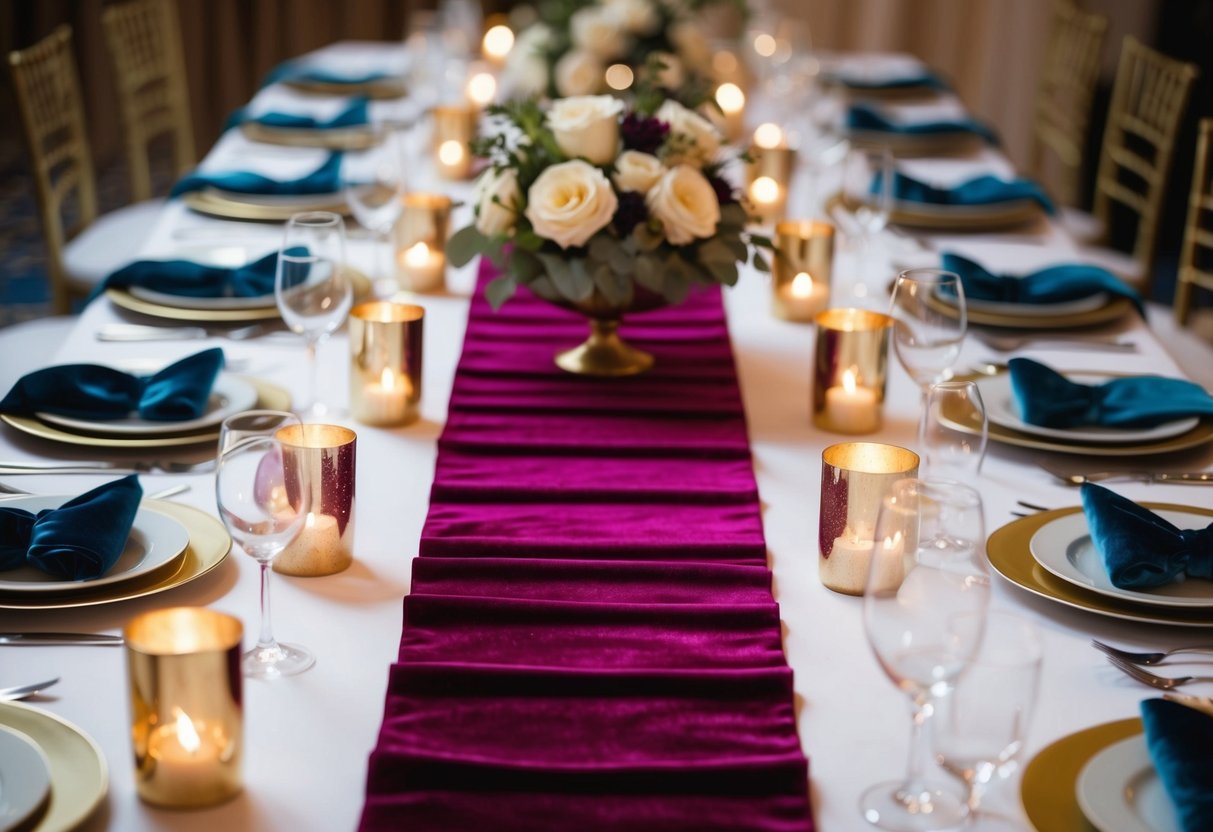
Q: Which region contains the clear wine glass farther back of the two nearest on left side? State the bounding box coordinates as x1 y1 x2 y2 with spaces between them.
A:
274 211 354 417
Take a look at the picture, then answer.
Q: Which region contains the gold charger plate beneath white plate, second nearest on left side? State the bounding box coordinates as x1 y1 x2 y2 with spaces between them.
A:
0 500 232 610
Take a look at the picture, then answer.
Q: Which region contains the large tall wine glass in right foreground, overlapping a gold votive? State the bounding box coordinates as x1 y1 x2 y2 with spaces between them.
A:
860 479 990 832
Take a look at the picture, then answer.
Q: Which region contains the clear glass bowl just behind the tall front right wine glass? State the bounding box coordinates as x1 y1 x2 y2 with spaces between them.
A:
918 381 990 481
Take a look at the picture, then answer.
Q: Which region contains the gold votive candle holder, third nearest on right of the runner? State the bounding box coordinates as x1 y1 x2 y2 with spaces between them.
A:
771 220 835 321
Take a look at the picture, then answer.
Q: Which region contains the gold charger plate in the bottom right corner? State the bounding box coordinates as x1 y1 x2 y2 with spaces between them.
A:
1019 717 1143 832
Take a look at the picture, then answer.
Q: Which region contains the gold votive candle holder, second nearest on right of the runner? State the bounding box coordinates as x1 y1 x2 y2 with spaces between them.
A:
813 308 893 434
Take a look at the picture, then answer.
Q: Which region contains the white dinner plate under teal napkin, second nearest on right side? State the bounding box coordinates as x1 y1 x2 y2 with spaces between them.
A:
1029 511 1213 609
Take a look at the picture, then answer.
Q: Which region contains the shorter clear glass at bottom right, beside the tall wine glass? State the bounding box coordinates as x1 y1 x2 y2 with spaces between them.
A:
932 611 1042 832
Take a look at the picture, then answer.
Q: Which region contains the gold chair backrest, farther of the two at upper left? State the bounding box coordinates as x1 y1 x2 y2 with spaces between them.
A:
101 0 197 201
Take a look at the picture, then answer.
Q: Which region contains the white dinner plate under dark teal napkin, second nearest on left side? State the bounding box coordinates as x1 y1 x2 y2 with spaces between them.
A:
0 495 189 593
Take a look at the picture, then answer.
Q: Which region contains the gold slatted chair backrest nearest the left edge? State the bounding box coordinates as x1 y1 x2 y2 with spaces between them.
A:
8 25 97 314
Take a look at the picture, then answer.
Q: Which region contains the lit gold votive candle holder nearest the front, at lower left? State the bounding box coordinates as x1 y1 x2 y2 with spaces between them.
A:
124 606 244 809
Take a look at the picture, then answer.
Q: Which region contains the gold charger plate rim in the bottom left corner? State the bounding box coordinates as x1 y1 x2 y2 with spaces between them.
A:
0 702 109 832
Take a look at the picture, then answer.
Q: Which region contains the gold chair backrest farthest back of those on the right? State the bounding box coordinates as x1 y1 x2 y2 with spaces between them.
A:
1029 0 1107 206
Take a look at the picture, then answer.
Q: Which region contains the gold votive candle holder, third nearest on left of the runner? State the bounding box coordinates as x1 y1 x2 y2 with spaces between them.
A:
349 301 426 427
